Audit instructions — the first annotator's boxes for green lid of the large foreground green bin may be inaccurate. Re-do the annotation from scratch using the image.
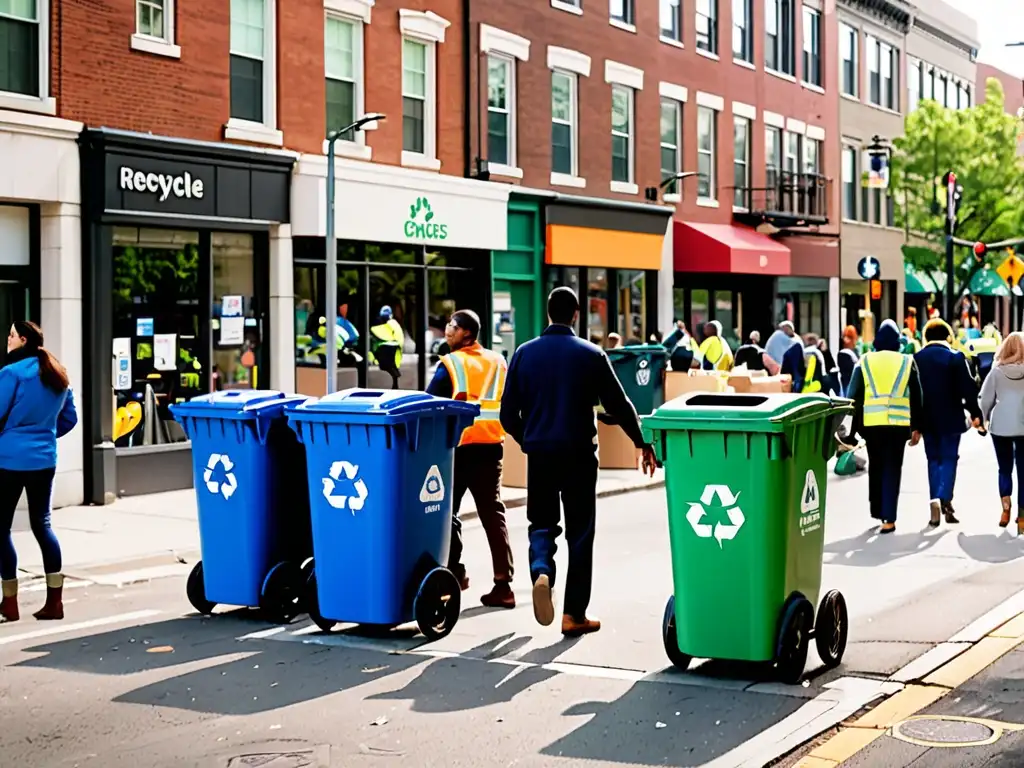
[642,392,853,432]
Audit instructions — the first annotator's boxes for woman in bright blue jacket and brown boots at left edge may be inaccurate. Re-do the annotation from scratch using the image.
[0,321,78,623]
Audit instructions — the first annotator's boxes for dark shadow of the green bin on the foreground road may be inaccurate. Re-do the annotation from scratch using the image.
[541,683,804,766]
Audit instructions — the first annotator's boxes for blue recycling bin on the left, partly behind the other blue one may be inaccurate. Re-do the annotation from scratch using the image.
[171,389,312,624]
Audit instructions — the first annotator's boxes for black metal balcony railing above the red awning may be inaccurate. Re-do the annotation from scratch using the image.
[735,169,831,226]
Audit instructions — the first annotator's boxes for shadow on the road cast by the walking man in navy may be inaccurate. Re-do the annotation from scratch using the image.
[367,633,579,714]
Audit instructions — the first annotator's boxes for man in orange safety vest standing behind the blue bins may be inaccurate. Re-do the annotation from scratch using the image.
[427,309,515,608]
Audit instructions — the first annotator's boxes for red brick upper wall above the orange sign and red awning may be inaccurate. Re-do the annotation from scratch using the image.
[470,0,840,231]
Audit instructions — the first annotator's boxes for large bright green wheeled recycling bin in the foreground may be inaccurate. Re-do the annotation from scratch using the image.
[643,392,852,683]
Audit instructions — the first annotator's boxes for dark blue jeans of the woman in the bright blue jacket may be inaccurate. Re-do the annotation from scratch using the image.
[0,469,61,582]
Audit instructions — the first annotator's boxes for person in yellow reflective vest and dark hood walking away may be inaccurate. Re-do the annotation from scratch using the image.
[845,319,923,534]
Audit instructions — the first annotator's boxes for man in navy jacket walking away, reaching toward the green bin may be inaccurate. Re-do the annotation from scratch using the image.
[501,288,655,637]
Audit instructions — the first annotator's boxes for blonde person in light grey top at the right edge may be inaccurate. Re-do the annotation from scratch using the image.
[981,332,1024,535]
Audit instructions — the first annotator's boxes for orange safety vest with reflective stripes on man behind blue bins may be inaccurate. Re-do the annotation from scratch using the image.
[441,344,508,445]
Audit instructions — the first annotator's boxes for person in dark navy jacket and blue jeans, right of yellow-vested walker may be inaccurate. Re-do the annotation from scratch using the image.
[913,317,978,527]
